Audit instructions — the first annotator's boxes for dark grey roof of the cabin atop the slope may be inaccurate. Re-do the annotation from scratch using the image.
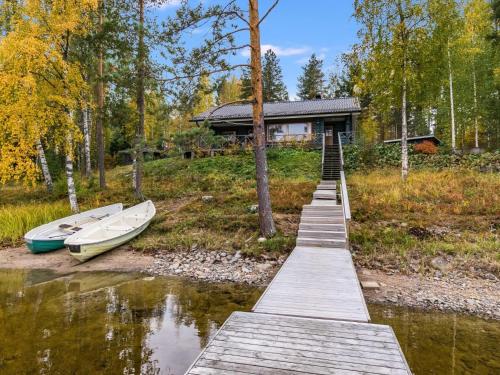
[192,98,361,121]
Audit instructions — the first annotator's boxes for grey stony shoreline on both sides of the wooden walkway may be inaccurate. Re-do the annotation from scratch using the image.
[146,250,500,320]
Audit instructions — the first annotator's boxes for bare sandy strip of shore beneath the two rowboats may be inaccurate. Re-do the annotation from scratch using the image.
[0,247,154,274]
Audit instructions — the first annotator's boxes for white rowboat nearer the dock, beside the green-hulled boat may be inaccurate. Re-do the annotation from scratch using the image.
[64,201,156,262]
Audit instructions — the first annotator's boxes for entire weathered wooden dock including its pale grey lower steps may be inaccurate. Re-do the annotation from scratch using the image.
[186,181,411,375]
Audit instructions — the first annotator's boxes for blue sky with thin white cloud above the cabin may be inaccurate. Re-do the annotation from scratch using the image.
[155,0,357,100]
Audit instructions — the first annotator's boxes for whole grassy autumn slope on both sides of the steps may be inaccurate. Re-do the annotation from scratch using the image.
[0,149,500,273]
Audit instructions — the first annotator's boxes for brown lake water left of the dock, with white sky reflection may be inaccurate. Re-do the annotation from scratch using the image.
[0,270,261,374]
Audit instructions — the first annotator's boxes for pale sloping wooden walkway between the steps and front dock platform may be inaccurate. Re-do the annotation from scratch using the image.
[252,247,370,322]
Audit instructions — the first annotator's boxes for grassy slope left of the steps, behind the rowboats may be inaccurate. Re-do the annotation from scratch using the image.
[0,149,321,255]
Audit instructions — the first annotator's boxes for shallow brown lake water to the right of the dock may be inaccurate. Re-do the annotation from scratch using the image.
[369,305,500,375]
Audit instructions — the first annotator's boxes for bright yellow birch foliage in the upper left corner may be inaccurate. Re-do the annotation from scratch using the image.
[0,0,97,183]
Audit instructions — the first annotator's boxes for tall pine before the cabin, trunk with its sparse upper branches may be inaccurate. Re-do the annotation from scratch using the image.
[165,0,279,237]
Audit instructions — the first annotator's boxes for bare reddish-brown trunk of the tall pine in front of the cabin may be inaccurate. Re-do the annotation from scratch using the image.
[249,0,276,238]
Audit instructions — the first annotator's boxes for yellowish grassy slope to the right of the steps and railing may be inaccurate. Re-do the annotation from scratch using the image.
[348,169,500,273]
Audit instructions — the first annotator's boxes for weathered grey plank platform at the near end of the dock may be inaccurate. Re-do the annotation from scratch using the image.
[186,312,411,375]
